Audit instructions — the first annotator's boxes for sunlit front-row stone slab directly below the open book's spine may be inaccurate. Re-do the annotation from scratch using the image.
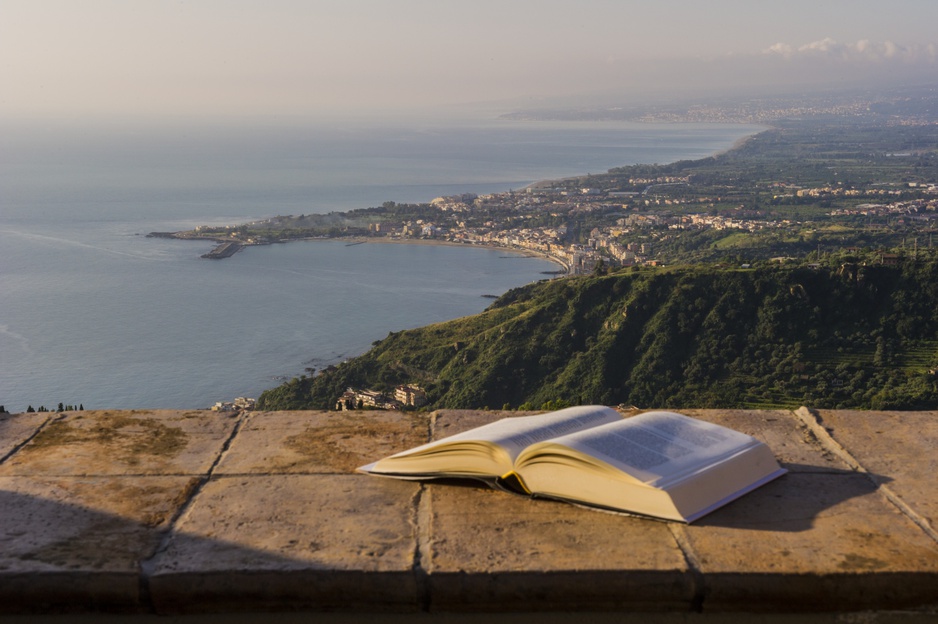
[422,482,694,611]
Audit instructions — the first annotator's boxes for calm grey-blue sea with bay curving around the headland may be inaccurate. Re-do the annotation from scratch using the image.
[0,116,760,412]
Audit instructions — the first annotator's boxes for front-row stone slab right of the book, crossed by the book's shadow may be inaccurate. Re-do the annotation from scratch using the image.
[682,471,938,611]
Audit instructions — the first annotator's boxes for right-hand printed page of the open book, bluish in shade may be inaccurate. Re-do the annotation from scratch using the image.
[532,412,759,486]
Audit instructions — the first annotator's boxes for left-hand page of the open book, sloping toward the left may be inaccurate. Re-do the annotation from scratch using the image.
[391,405,622,460]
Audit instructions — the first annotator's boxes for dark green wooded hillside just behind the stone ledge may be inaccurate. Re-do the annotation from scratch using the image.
[259,257,938,410]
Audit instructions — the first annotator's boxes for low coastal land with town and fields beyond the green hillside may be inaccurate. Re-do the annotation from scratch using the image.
[151,92,938,275]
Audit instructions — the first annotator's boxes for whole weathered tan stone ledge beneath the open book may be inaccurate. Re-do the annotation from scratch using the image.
[0,408,938,614]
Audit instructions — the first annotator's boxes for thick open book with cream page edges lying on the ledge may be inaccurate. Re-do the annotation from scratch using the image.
[359,406,786,522]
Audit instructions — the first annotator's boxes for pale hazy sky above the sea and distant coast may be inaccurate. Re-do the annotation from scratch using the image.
[0,0,938,118]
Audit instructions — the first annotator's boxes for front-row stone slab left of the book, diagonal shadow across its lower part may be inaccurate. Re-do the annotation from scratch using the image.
[148,475,420,613]
